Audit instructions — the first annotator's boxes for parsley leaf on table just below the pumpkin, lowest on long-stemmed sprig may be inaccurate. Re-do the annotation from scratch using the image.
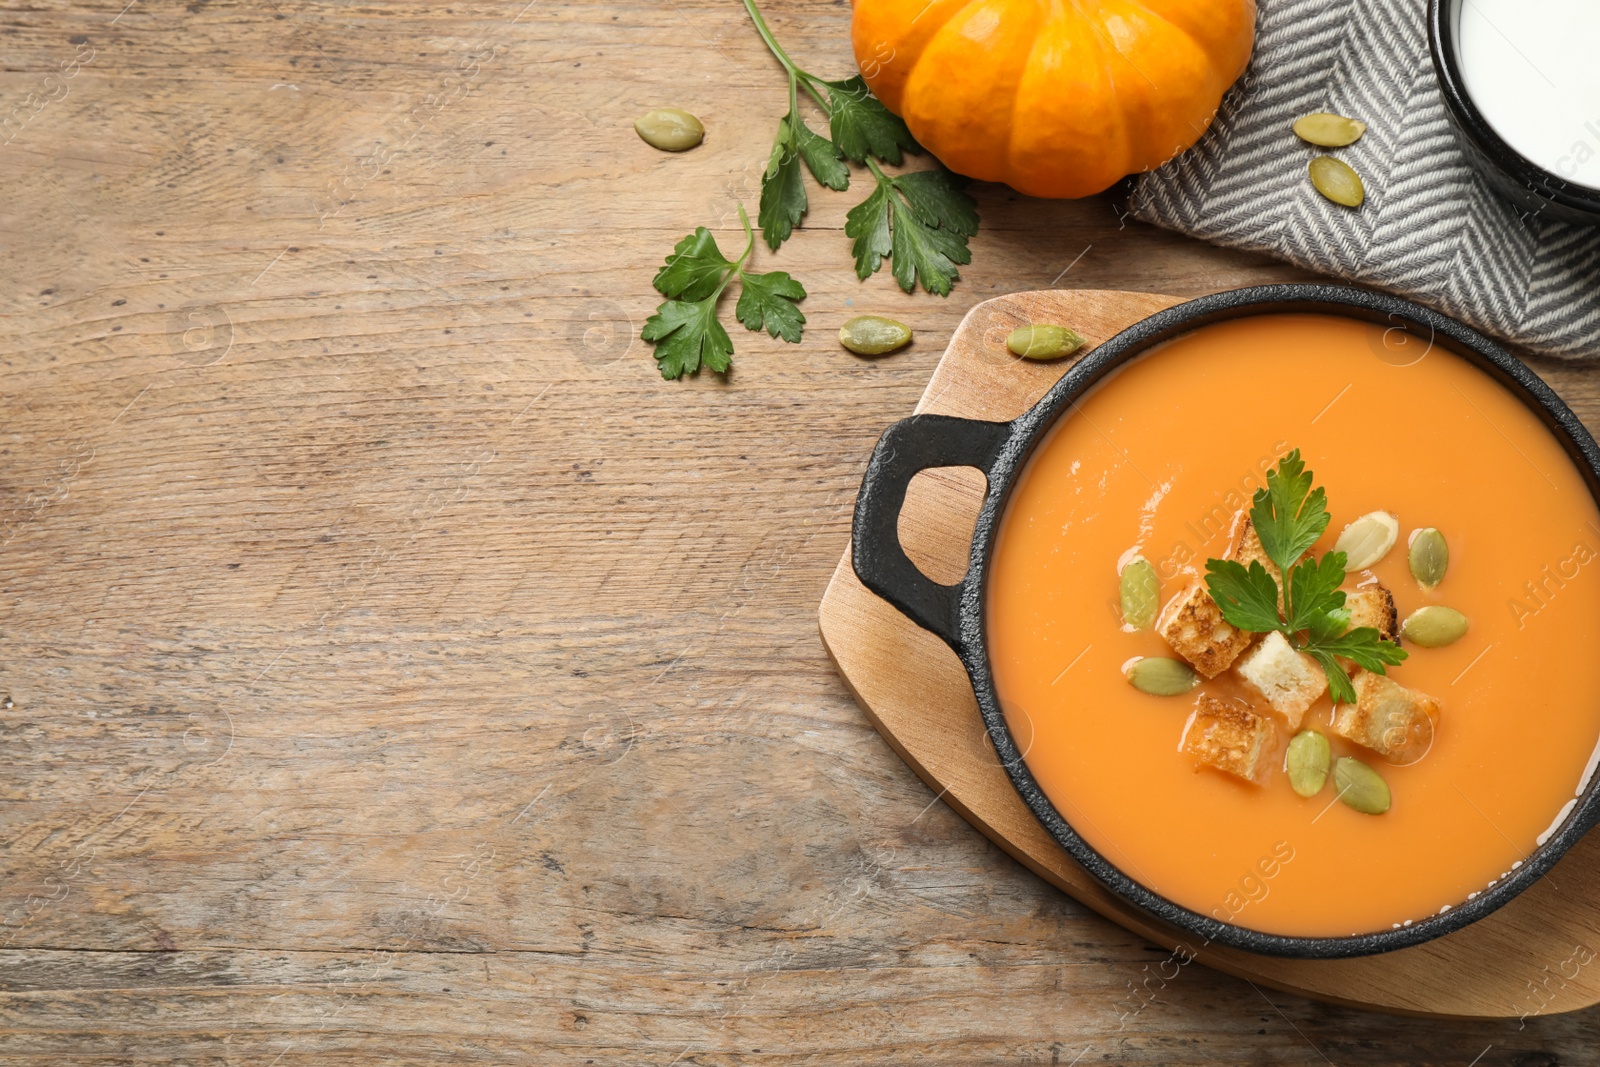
[845,160,978,296]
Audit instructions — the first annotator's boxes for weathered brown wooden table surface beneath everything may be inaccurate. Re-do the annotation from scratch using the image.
[0,0,1600,1067]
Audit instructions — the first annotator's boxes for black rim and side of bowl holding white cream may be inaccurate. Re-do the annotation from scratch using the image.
[1427,0,1600,226]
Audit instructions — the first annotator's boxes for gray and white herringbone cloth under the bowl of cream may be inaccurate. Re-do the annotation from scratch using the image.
[1131,0,1600,357]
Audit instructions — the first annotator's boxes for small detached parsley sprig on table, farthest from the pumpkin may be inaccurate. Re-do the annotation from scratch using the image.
[642,205,805,381]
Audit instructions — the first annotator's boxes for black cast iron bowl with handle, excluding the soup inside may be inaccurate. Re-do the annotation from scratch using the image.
[851,285,1600,960]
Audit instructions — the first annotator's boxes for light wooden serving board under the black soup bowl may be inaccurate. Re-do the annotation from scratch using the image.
[819,290,1600,1019]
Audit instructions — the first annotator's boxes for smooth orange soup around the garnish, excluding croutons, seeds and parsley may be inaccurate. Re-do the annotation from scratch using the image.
[987,315,1600,937]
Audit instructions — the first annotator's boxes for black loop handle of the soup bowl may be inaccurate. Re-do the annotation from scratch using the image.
[851,414,1011,651]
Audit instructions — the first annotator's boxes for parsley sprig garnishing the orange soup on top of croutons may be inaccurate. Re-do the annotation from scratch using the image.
[1205,448,1406,704]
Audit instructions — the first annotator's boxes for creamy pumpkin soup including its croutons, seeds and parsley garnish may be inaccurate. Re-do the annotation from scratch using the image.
[986,315,1600,937]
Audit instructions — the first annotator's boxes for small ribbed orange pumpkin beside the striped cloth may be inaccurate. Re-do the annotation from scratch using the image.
[851,0,1256,197]
